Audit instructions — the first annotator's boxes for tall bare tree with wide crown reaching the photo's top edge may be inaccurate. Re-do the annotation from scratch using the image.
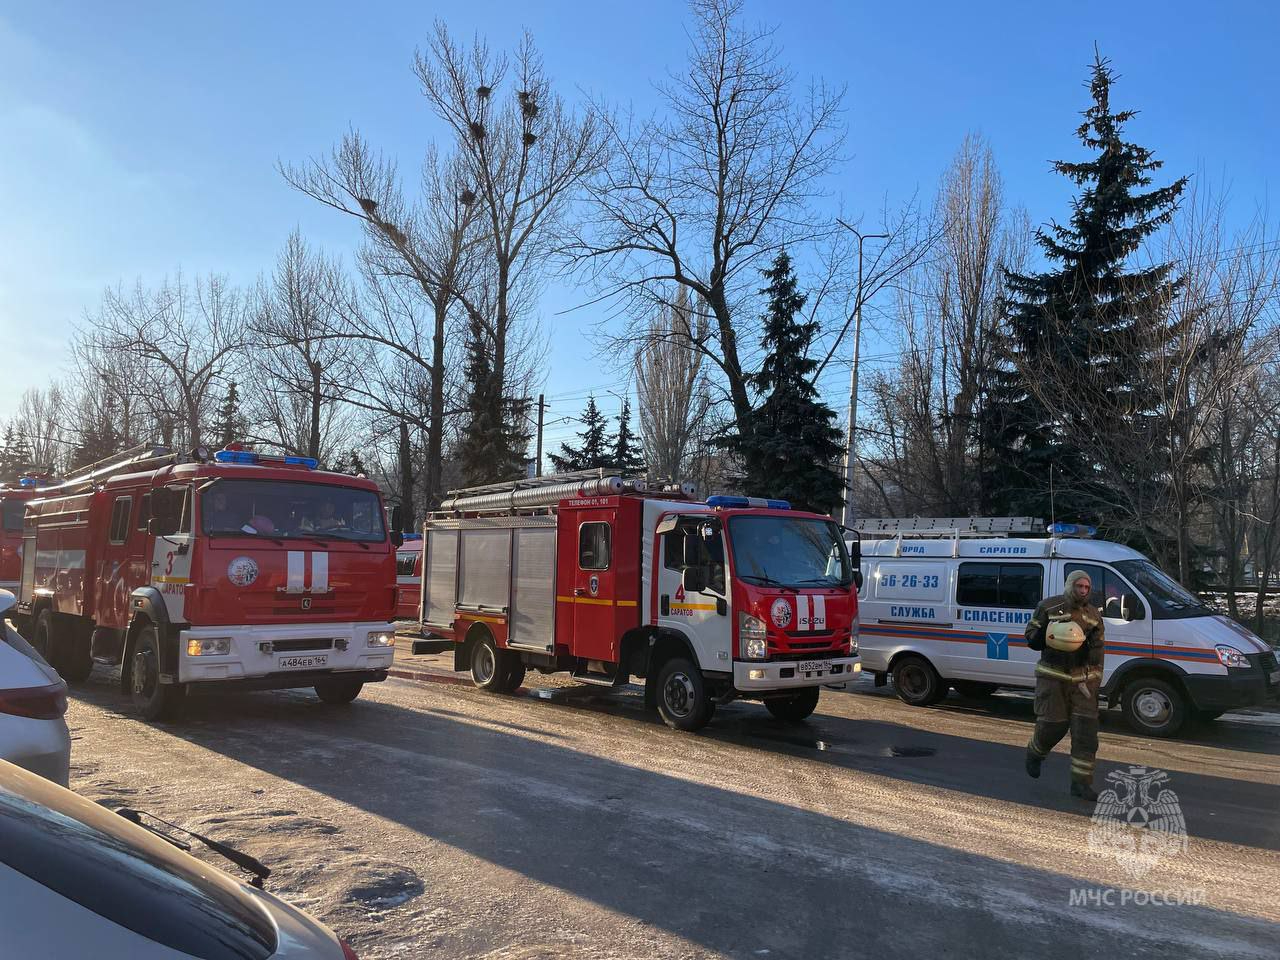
[568,0,842,430]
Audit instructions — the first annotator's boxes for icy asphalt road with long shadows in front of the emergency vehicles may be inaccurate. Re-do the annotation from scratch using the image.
[68,673,1280,960]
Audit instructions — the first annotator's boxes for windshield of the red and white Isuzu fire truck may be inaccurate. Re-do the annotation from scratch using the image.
[728,516,852,588]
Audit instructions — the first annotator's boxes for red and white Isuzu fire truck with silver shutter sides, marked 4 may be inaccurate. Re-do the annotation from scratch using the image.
[415,471,860,730]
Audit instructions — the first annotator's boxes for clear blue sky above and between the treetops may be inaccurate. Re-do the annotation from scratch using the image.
[0,0,1280,453]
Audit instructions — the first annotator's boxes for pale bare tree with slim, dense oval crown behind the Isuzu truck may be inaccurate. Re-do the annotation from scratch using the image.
[635,287,710,481]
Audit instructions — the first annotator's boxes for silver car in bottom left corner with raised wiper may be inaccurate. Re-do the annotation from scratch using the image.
[0,760,356,960]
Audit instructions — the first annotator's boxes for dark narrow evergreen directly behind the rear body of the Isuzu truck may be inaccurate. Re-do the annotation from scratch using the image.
[457,324,530,485]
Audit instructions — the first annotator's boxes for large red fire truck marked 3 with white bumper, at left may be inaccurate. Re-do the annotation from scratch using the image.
[15,444,398,719]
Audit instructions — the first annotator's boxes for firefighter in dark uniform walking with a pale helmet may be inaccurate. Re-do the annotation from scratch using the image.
[1025,570,1103,800]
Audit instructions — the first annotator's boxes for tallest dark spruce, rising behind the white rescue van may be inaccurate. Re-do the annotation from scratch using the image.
[980,55,1187,522]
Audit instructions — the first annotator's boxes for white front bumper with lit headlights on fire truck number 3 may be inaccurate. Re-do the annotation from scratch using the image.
[178,621,396,689]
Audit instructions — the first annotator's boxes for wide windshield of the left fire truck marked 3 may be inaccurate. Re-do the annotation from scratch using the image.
[200,479,387,541]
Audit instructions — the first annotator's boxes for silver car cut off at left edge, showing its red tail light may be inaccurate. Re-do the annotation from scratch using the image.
[0,590,72,786]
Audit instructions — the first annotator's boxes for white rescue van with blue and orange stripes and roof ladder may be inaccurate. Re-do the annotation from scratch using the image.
[856,517,1280,736]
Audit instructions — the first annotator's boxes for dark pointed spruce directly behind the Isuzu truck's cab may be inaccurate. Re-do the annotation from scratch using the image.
[728,250,845,513]
